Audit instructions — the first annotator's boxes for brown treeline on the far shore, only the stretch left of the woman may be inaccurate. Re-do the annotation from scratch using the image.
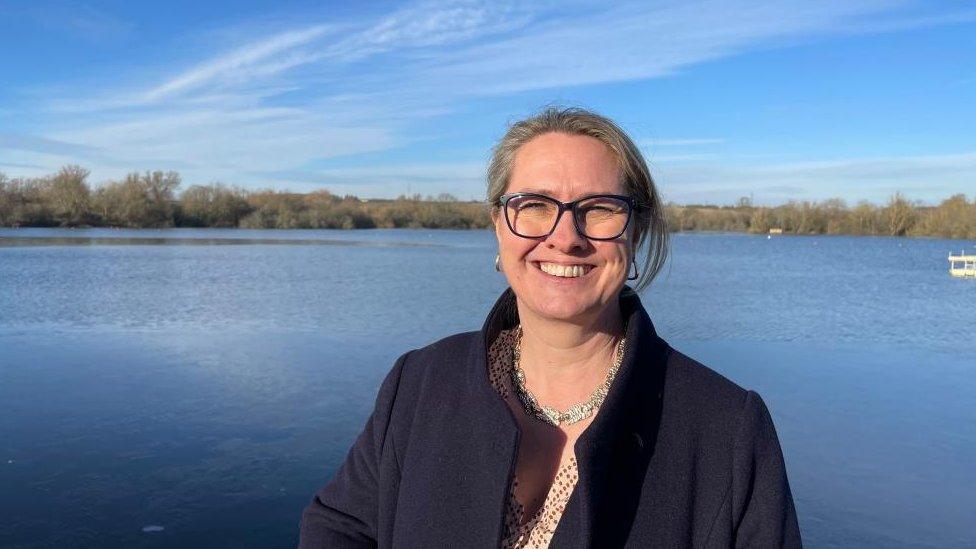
[0,166,491,229]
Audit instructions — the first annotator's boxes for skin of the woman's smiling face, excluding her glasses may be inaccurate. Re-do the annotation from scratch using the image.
[493,133,633,324]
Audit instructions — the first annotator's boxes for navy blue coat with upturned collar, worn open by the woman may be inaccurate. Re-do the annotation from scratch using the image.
[300,289,800,548]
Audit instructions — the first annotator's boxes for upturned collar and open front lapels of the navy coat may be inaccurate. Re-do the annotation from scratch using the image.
[469,286,670,547]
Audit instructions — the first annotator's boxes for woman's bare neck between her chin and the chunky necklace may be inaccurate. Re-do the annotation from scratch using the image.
[510,302,623,409]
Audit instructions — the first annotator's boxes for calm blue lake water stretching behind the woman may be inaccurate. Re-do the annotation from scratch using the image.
[0,229,976,547]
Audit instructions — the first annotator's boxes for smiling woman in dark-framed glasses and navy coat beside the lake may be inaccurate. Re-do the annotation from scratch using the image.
[301,108,800,548]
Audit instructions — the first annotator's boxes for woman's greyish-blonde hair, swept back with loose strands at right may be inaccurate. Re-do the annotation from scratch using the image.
[488,107,669,292]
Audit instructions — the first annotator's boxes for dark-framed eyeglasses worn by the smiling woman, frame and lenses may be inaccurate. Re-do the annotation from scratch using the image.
[498,193,635,240]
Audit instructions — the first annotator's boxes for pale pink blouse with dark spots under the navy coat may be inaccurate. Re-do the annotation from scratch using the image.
[488,330,579,549]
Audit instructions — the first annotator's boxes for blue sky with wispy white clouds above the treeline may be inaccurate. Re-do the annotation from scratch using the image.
[0,0,976,204]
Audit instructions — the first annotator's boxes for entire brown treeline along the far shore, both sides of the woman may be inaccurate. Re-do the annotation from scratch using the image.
[0,166,976,239]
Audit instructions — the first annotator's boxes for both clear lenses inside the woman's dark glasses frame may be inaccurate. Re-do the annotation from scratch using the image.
[505,196,630,238]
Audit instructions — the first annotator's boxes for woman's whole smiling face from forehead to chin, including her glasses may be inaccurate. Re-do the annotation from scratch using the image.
[493,132,640,330]
